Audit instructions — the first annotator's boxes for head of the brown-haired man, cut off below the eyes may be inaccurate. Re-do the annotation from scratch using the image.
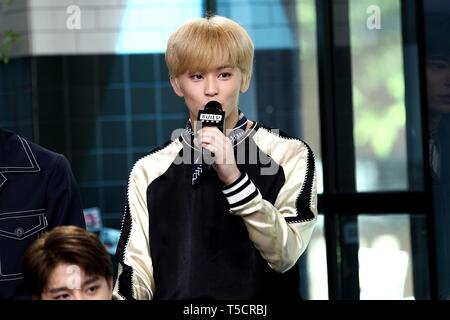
[23,226,112,300]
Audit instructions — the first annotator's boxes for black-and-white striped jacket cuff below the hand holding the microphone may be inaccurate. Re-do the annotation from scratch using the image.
[222,173,258,208]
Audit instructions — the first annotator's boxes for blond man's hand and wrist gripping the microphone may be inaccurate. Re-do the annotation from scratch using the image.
[194,127,241,185]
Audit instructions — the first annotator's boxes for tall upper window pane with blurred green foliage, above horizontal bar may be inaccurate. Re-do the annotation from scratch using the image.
[349,0,408,191]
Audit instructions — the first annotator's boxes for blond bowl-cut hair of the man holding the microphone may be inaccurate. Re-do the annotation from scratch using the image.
[166,16,254,86]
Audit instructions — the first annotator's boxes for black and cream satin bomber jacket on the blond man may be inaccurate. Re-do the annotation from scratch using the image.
[113,123,317,300]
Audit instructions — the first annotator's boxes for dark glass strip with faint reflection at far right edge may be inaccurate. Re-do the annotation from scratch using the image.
[424,1,450,299]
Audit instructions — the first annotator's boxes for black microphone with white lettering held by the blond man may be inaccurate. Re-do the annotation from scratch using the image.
[197,100,225,168]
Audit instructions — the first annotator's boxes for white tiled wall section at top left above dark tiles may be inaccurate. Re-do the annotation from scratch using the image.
[0,0,202,55]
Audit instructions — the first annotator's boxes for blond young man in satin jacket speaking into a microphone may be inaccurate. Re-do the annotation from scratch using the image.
[114,16,317,299]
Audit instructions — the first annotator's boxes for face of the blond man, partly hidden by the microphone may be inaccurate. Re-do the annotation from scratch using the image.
[170,66,247,128]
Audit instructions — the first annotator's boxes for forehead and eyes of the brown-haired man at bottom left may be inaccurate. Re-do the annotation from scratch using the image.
[40,263,112,300]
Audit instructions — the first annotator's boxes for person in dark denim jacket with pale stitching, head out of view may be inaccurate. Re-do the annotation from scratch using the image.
[0,129,85,300]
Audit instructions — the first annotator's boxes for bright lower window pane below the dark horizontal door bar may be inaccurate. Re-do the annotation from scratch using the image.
[358,215,414,300]
